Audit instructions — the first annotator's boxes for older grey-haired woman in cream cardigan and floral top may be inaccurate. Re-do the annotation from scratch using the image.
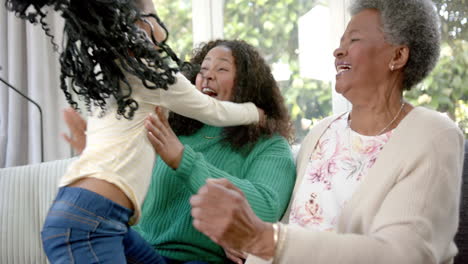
[191,0,463,264]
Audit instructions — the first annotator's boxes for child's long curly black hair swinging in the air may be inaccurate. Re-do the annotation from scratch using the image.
[5,0,185,119]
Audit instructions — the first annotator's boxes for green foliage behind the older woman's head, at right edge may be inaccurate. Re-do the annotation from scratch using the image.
[405,0,468,138]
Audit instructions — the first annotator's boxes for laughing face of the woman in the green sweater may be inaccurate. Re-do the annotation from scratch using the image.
[195,46,236,101]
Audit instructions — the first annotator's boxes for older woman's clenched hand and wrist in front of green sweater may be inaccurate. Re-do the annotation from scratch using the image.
[190,179,275,259]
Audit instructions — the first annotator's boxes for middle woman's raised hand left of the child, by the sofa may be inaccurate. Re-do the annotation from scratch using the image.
[62,107,86,155]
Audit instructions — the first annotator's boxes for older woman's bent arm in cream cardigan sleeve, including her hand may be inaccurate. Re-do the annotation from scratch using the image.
[188,125,463,264]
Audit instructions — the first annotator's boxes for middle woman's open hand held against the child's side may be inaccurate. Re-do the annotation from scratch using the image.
[145,107,184,169]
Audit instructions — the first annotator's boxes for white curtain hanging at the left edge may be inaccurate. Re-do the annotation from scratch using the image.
[0,5,71,168]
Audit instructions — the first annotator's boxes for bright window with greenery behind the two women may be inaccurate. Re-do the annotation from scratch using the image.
[154,0,468,139]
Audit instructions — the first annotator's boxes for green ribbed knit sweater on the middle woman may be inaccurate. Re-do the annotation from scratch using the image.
[134,126,296,263]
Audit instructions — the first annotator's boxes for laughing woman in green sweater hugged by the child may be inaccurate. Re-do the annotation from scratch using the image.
[62,40,296,264]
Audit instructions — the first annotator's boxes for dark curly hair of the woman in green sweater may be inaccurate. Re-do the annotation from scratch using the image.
[169,40,293,149]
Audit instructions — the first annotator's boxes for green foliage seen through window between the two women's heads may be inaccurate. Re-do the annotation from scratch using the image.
[224,0,332,141]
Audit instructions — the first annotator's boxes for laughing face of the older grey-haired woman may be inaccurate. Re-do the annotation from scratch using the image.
[333,9,393,102]
